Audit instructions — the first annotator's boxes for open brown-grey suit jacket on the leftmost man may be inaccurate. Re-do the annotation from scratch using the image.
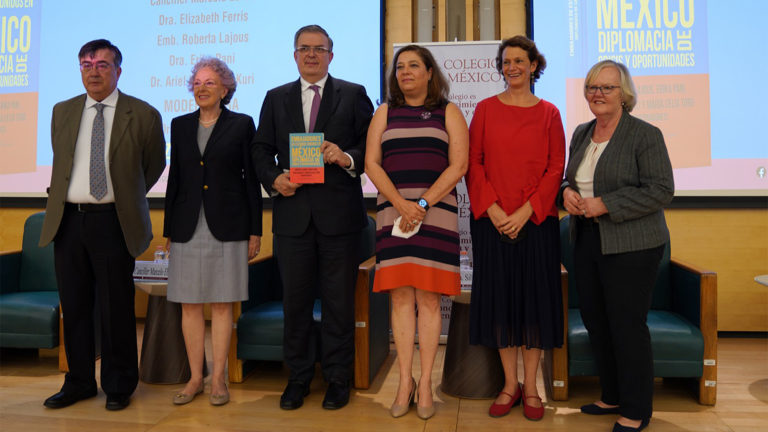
[40,92,165,257]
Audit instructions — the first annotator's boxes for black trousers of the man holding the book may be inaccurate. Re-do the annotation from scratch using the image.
[275,221,361,384]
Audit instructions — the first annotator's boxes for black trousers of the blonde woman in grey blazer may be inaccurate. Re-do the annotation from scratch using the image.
[573,220,664,420]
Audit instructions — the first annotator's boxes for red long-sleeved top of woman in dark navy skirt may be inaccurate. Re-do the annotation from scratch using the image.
[466,96,565,225]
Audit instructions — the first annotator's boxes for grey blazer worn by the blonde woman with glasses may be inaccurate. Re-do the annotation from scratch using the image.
[560,112,675,254]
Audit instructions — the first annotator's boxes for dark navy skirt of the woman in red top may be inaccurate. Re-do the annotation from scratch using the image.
[469,216,563,350]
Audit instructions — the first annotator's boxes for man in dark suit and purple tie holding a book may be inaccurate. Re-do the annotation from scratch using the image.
[253,25,373,409]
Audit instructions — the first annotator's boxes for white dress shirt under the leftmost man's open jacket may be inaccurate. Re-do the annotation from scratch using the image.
[67,89,120,204]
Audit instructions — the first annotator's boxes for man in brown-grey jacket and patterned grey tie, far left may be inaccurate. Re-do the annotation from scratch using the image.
[40,39,165,410]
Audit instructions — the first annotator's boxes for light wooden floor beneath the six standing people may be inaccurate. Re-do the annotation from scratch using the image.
[0,324,768,432]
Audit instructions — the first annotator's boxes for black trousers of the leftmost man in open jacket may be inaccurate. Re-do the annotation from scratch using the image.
[53,205,139,396]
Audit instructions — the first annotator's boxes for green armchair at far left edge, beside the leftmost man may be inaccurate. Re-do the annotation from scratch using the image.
[0,212,59,349]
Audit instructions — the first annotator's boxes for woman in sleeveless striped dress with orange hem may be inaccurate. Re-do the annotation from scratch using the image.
[365,45,469,419]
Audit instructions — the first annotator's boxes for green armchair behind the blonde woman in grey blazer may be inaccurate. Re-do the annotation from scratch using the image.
[544,216,717,405]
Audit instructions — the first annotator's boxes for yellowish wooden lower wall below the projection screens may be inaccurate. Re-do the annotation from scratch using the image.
[0,204,768,332]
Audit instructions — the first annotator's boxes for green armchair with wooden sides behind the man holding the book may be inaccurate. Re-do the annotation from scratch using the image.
[229,216,389,389]
